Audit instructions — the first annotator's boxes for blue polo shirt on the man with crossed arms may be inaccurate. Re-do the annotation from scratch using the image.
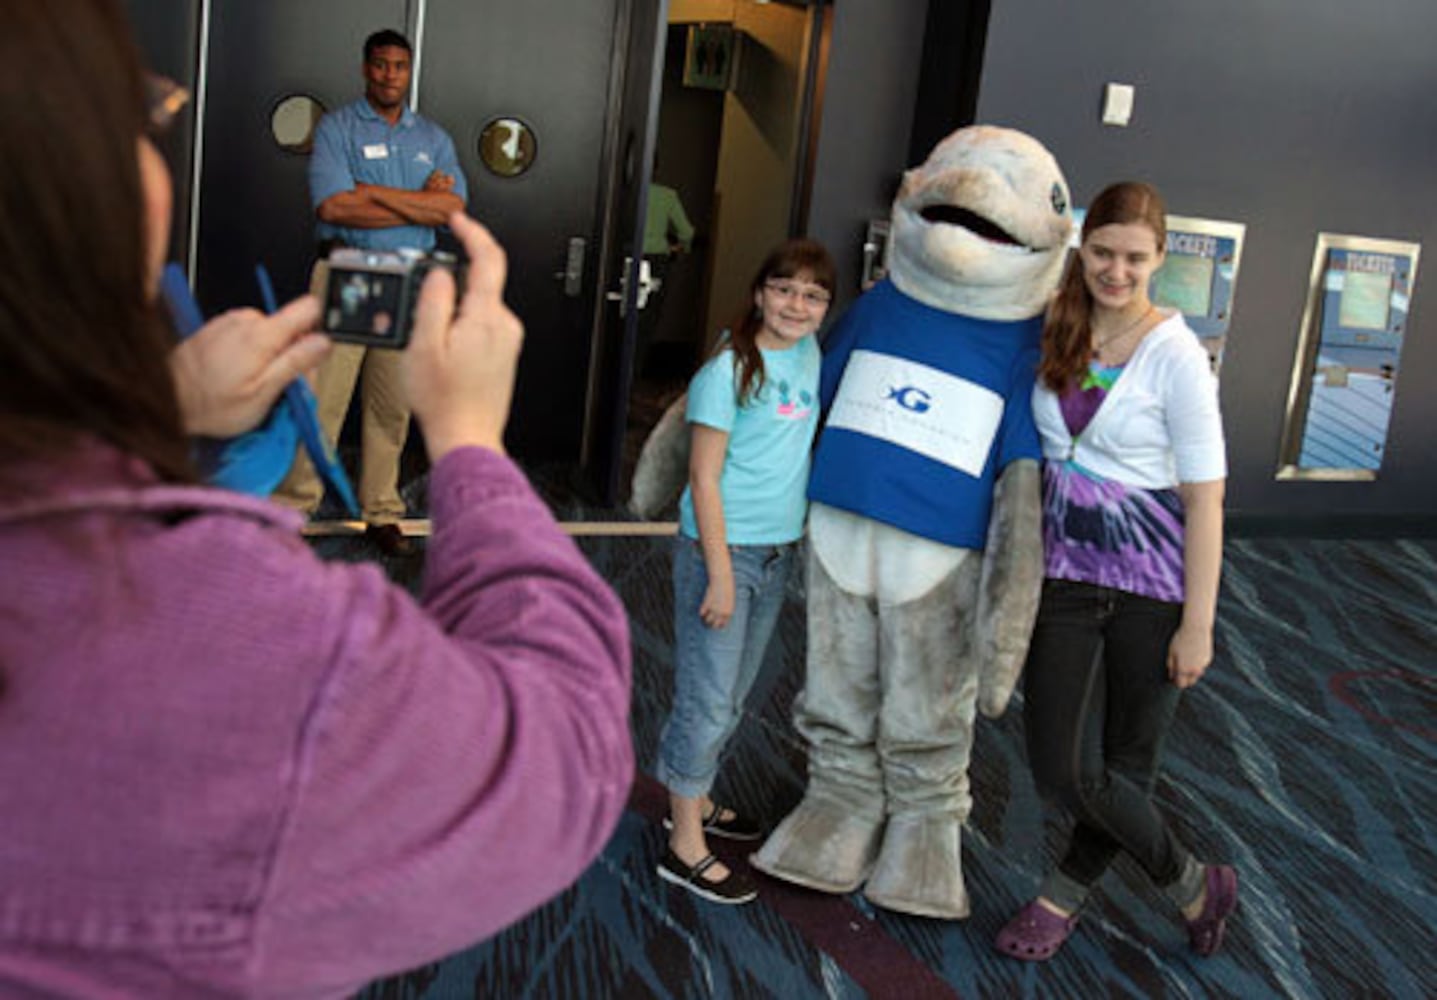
[309,98,468,250]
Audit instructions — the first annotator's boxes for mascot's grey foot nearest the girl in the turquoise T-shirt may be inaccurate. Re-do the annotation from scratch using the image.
[749,796,884,892]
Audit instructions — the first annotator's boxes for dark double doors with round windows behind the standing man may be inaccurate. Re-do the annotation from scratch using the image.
[185,0,667,491]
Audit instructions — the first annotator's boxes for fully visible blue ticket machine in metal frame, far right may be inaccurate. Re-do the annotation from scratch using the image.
[1277,233,1421,480]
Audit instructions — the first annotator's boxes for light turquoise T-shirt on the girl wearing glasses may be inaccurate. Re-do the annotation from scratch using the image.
[678,336,822,545]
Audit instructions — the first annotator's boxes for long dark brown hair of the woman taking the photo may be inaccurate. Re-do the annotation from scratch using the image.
[0,0,194,491]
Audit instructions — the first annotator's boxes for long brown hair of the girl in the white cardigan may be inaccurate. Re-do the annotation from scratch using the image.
[1038,181,1167,392]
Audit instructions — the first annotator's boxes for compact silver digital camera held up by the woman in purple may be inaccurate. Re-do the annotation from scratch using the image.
[313,247,464,351]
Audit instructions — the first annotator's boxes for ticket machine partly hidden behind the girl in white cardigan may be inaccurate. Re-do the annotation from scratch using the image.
[1148,216,1247,374]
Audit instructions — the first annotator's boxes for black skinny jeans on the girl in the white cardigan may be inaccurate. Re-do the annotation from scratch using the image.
[1023,579,1188,886]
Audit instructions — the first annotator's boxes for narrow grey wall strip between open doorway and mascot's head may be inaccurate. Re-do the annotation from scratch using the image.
[808,0,925,303]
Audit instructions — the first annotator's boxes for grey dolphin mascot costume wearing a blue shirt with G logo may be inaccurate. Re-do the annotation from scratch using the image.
[634,126,1072,918]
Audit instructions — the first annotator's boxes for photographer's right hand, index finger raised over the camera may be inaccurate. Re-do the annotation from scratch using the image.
[404,213,523,461]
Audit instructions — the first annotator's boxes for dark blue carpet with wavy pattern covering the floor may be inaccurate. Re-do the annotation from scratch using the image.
[330,539,1437,1000]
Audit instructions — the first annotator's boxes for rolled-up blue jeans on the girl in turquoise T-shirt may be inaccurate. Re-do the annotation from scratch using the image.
[658,534,798,799]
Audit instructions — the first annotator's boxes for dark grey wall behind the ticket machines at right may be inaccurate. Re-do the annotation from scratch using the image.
[977,0,1437,526]
